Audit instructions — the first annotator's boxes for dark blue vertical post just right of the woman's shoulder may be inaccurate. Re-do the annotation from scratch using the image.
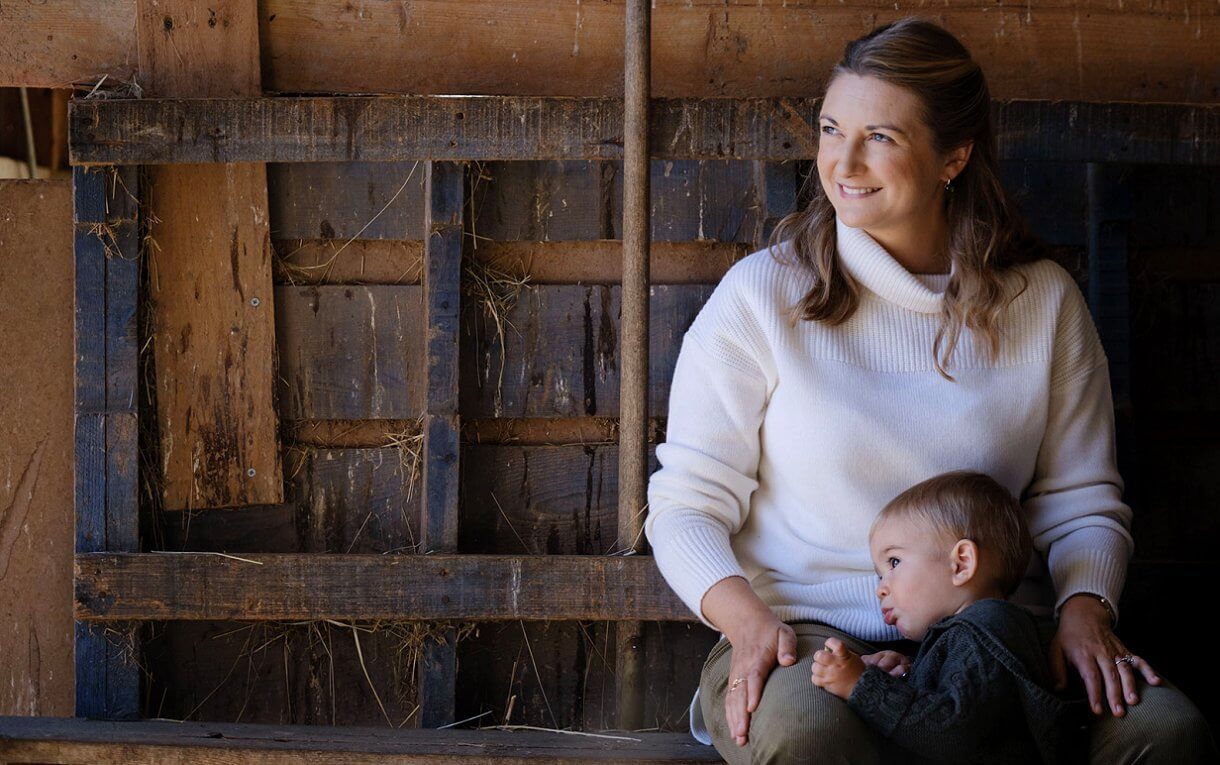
[1086,162,1135,472]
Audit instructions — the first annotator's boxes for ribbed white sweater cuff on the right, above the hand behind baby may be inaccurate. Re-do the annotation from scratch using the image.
[1049,526,1131,623]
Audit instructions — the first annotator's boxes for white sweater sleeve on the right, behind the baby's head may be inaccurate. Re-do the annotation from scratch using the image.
[1024,273,1133,615]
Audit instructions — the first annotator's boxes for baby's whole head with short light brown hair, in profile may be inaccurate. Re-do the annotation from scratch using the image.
[869,471,1033,641]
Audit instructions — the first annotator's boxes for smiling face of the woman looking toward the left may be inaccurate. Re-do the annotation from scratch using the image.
[817,74,965,242]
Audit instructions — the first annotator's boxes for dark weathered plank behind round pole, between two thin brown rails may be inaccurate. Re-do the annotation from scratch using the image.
[461,286,712,417]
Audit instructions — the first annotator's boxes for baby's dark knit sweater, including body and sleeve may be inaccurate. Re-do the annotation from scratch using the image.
[848,598,1089,764]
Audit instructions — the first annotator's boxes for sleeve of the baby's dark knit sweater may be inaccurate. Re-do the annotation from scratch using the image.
[848,631,1021,761]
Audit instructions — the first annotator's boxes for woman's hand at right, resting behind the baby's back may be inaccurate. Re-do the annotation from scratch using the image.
[1049,594,1161,717]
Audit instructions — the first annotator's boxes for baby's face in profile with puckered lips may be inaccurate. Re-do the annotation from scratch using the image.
[869,517,963,641]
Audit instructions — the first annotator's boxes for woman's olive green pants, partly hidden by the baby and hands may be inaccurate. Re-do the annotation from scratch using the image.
[699,621,1218,765]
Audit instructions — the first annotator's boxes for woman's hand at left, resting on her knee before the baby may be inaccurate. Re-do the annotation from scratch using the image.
[703,576,797,747]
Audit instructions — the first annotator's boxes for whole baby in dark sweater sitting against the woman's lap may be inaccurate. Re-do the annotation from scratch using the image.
[813,471,1088,763]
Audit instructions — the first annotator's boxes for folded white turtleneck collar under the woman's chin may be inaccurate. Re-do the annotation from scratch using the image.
[834,217,952,314]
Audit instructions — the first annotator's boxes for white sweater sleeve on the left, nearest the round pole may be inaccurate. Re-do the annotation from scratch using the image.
[644,263,769,628]
